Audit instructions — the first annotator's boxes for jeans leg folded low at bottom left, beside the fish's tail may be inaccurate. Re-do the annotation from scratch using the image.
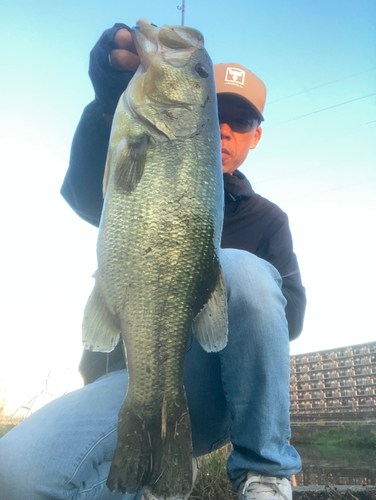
[0,370,143,500]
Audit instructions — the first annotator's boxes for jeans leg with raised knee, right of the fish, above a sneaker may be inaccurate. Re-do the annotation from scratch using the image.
[219,249,301,499]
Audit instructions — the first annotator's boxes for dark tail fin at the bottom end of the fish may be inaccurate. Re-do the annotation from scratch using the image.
[107,396,193,499]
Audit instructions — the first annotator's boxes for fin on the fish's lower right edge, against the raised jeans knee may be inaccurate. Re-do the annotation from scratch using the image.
[192,268,228,352]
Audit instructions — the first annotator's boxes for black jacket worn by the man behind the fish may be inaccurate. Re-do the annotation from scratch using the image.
[61,25,306,383]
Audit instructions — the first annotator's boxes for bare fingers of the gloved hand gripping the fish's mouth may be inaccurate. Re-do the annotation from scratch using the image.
[110,19,150,71]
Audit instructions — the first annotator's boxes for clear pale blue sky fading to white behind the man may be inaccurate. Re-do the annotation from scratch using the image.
[0,0,376,414]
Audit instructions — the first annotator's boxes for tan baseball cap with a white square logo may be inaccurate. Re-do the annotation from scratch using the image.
[214,63,266,121]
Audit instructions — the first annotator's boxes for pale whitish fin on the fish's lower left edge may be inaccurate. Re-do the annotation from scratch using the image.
[82,285,120,352]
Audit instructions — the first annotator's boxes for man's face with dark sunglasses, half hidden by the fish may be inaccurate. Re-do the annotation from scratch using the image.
[217,94,262,175]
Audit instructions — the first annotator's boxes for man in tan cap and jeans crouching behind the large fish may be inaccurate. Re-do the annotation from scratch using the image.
[0,20,305,500]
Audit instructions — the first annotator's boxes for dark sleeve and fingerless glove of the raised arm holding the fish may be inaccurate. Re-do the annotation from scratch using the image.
[60,23,134,226]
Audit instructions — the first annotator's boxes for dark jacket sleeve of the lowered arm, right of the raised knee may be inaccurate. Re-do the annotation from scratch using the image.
[259,210,307,340]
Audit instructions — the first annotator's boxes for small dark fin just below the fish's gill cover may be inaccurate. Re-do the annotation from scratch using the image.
[115,133,149,193]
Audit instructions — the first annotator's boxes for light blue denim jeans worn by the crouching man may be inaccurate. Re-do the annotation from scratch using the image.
[0,249,301,500]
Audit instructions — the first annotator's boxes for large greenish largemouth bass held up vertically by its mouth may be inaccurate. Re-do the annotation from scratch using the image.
[82,24,228,500]
